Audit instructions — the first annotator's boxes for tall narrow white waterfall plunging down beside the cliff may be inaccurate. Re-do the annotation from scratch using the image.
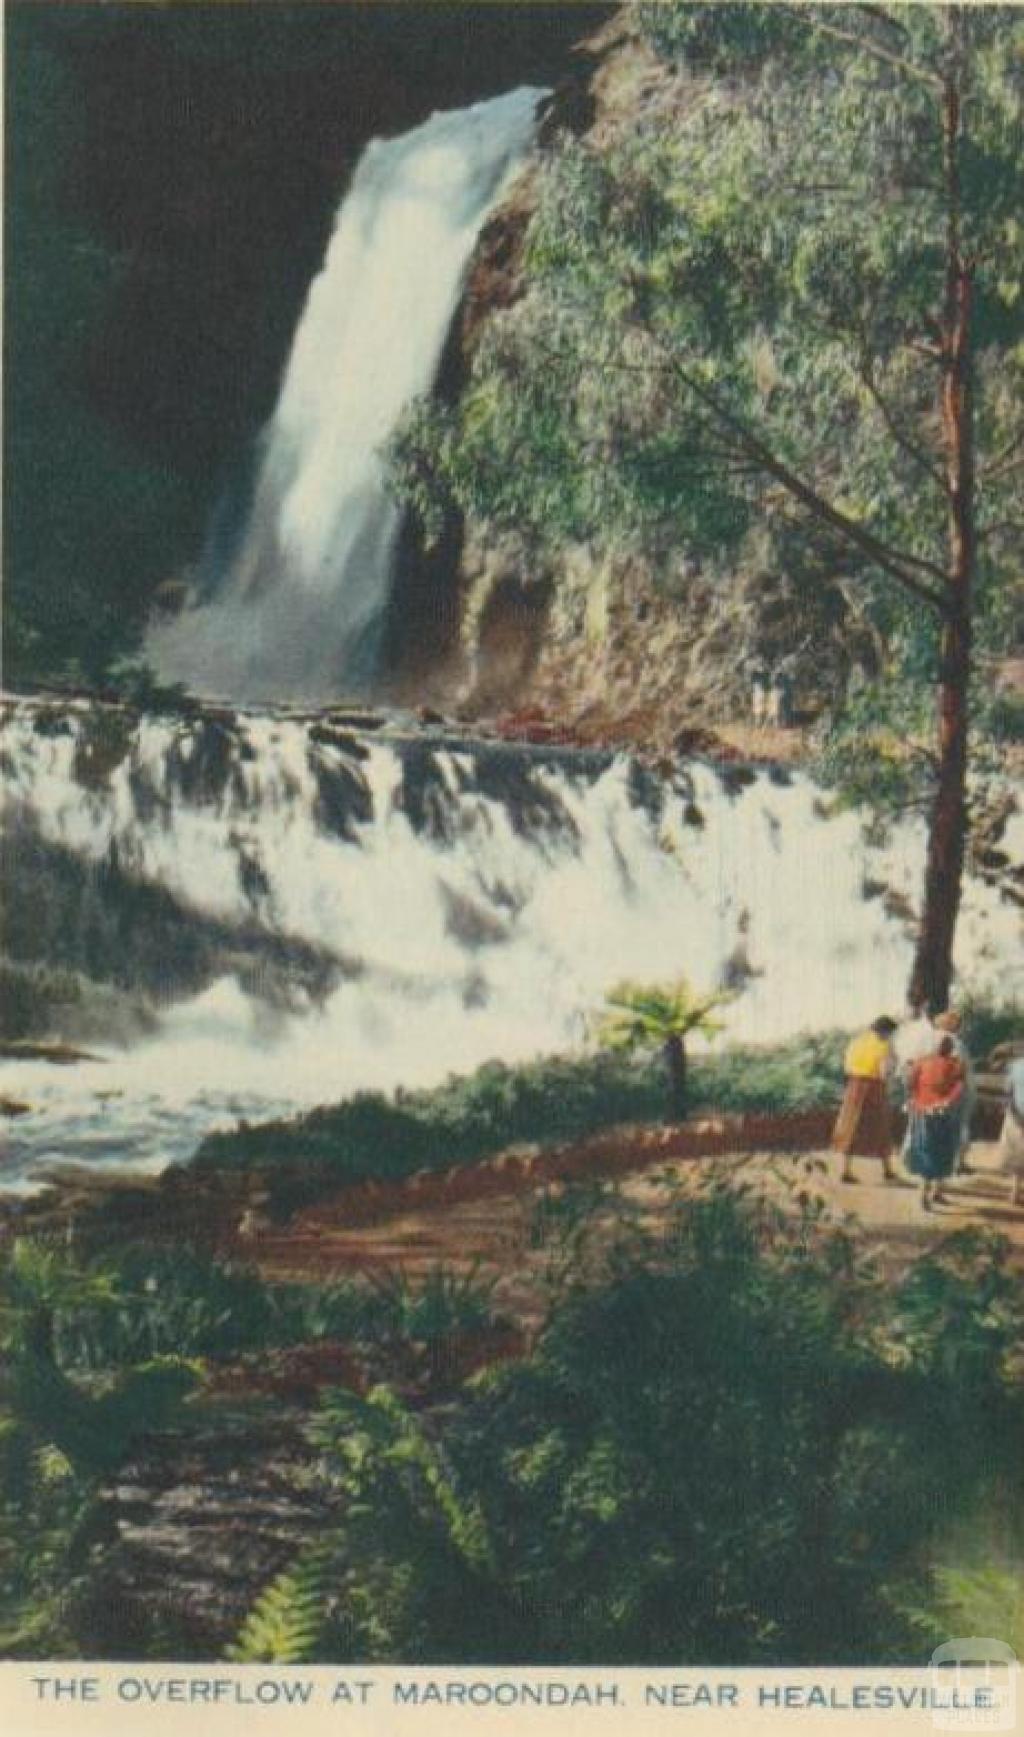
[148,89,543,703]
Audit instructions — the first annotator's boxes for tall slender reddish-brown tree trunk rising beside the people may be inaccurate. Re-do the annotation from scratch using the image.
[909,7,977,1007]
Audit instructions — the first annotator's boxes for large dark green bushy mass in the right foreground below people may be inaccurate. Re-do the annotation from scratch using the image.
[230,1183,1024,1664]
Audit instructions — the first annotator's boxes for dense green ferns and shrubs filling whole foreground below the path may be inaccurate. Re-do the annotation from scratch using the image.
[0,1171,1024,1664]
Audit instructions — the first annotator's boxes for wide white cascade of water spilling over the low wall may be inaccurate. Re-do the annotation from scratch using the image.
[0,703,1024,1188]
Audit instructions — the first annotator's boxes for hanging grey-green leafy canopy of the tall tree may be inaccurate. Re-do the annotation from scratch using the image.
[394,0,1024,788]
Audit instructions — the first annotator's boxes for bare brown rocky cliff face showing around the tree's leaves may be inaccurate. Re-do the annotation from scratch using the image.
[443,9,880,743]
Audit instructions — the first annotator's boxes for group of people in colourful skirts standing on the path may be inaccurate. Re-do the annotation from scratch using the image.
[831,1004,1024,1212]
